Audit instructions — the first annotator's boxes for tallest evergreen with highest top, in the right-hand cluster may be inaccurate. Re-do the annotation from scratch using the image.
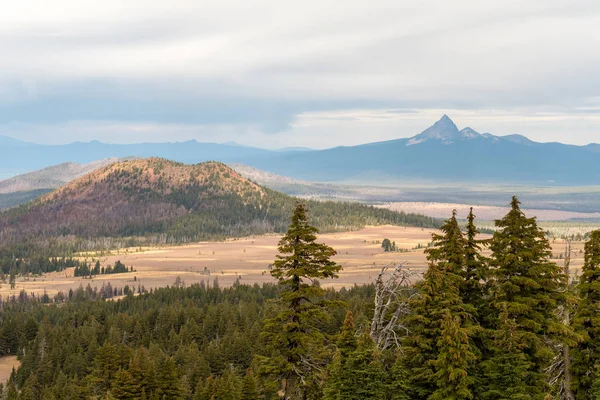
[490,197,574,399]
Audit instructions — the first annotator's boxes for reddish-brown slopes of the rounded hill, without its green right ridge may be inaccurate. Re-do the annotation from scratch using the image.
[0,158,264,245]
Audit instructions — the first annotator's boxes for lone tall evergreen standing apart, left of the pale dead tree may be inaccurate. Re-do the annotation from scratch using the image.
[264,204,341,400]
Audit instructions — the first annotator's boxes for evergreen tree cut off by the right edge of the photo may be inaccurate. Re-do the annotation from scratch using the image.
[572,230,600,400]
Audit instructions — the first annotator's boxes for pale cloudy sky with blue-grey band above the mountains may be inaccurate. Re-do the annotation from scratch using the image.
[0,0,600,148]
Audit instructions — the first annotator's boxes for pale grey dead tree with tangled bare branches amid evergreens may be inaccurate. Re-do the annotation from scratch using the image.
[370,263,417,350]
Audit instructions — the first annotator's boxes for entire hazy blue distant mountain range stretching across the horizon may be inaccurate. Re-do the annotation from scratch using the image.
[0,115,600,186]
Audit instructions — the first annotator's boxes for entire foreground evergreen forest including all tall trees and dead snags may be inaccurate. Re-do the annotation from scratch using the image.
[7,198,600,400]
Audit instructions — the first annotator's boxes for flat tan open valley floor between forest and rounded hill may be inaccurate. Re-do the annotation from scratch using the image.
[0,225,583,297]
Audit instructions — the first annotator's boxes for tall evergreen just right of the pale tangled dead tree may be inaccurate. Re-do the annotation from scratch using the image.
[406,211,479,400]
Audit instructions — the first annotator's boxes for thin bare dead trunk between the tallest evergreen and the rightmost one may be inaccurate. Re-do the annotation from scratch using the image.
[547,239,575,400]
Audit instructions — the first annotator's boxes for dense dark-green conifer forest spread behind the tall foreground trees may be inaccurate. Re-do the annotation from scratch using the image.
[0,285,373,400]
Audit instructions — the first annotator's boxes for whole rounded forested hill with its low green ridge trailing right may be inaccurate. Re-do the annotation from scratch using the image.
[0,158,438,250]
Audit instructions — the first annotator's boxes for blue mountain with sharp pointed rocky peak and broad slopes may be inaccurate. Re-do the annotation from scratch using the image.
[241,115,600,186]
